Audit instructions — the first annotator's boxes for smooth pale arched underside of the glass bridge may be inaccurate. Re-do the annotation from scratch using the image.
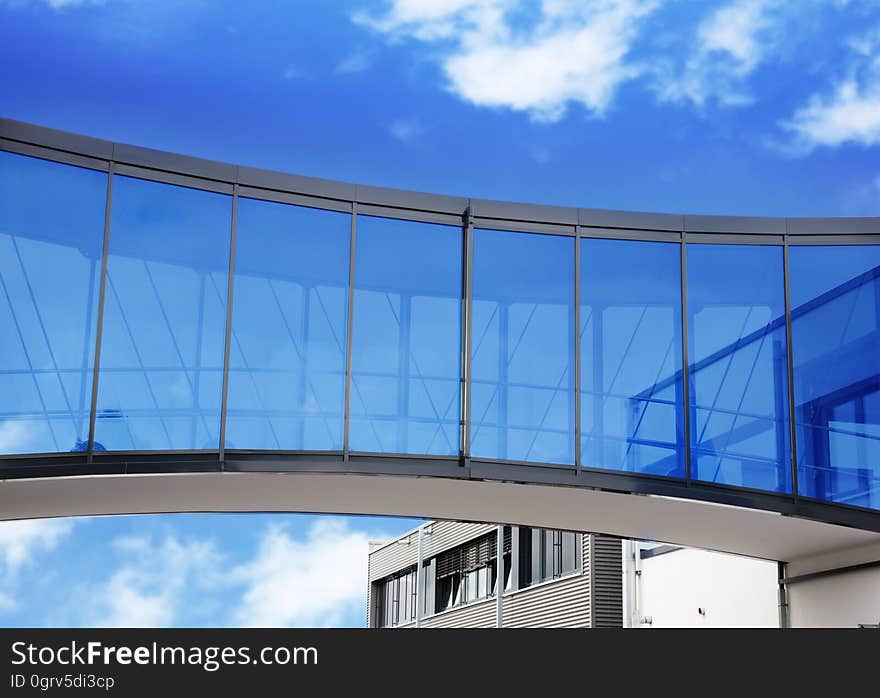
[0,463,880,570]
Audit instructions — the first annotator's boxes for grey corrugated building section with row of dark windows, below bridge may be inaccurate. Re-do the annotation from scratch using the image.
[367,521,623,628]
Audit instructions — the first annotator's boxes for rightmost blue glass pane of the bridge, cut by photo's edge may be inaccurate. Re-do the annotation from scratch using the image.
[789,245,880,509]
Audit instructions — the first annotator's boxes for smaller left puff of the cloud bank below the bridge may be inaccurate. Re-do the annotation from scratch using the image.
[86,535,222,627]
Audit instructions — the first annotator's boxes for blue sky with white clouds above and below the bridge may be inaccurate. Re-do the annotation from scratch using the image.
[0,0,880,625]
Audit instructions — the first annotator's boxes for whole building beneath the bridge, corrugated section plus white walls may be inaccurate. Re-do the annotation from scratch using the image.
[367,521,880,628]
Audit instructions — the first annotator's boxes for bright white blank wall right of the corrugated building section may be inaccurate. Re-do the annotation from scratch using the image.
[635,548,779,628]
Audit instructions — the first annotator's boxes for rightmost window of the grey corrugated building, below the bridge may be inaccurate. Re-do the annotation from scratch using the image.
[518,528,581,588]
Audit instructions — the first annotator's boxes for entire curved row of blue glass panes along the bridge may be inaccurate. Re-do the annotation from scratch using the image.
[0,126,880,510]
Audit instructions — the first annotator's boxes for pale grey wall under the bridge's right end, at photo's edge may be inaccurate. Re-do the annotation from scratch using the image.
[788,567,880,628]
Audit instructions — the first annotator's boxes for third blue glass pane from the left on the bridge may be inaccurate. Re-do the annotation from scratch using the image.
[226,199,351,450]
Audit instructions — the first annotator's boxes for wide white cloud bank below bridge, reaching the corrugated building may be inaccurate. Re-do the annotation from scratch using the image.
[68,518,396,627]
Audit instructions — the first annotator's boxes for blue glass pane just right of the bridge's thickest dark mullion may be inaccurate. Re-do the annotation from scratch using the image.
[471,230,575,463]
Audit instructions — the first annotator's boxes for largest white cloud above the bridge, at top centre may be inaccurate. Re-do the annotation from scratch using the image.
[355,0,662,121]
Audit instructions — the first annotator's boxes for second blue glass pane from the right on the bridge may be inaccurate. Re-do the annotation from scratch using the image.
[687,244,791,492]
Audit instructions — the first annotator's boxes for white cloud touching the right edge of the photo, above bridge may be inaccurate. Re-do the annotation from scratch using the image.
[781,28,880,154]
